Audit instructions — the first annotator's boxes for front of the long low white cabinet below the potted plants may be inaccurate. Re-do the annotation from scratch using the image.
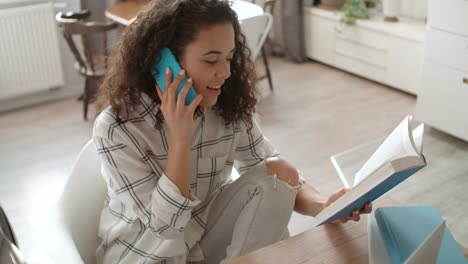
[304,6,426,94]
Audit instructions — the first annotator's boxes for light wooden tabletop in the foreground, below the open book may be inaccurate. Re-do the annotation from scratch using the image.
[228,219,368,264]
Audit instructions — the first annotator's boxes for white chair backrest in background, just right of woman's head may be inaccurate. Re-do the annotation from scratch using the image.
[240,13,273,59]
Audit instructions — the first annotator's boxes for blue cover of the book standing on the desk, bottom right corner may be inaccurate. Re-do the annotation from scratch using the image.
[375,206,468,264]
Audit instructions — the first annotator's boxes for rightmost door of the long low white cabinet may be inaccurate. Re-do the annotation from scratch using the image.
[385,38,424,94]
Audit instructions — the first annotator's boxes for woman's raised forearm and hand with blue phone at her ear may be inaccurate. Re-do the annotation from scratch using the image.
[151,49,203,199]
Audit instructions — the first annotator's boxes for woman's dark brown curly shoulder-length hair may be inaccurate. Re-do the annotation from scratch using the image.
[96,0,257,129]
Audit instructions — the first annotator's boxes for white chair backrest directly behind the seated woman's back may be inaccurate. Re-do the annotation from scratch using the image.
[59,141,107,264]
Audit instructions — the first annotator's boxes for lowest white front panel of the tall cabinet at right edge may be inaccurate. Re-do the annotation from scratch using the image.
[416,60,468,140]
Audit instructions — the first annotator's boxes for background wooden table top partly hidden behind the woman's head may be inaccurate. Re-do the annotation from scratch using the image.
[105,0,263,26]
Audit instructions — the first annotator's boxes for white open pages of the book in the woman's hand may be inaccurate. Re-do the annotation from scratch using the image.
[353,116,422,186]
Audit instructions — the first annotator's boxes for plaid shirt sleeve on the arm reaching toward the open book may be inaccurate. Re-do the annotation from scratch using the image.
[234,116,279,175]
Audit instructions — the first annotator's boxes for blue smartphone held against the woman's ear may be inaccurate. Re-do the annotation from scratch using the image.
[151,48,197,105]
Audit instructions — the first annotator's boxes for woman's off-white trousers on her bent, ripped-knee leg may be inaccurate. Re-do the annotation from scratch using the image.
[194,163,300,264]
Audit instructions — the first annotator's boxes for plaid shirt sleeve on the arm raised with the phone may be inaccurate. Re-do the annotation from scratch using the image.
[93,122,200,238]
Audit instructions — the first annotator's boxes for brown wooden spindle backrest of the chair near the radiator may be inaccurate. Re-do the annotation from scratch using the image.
[55,10,118,75]
